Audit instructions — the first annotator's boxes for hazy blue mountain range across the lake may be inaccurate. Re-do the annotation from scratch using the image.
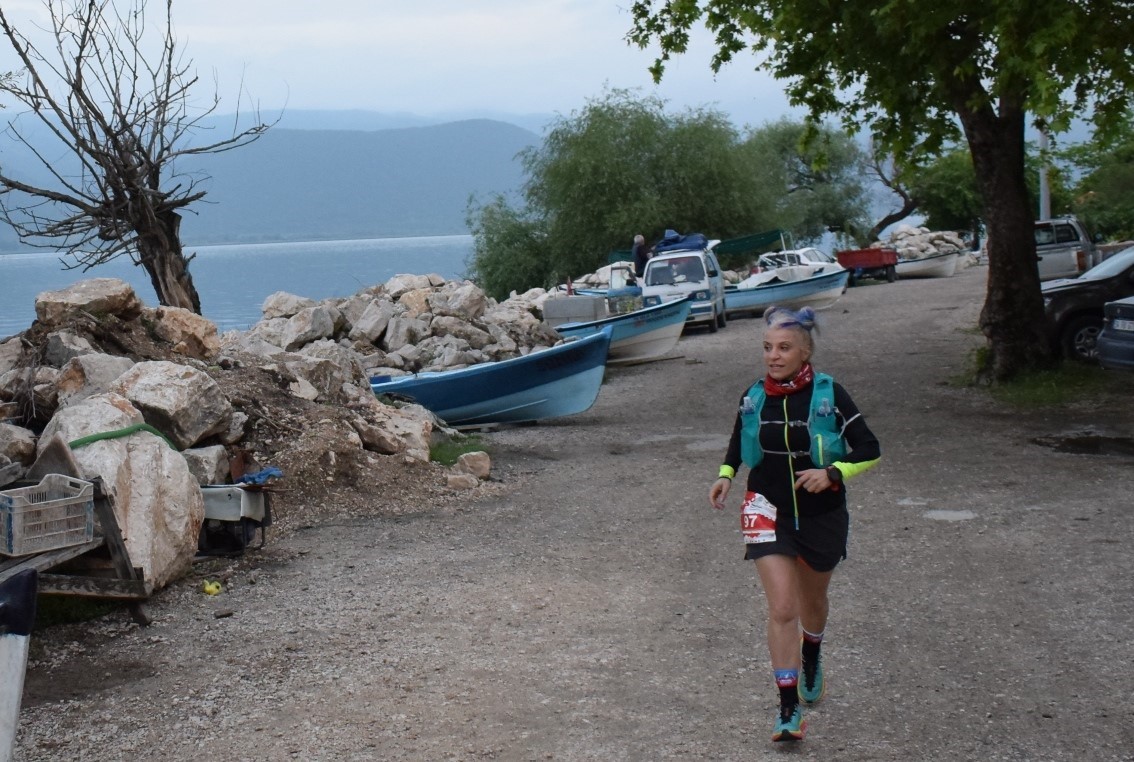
[0,111,540,251]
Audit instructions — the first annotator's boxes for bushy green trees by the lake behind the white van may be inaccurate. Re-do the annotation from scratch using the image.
[468,91,865,298]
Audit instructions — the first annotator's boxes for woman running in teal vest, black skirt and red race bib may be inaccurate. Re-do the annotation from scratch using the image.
[709,307,881,740]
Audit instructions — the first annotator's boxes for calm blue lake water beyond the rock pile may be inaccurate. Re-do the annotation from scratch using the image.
[0,236,473,338]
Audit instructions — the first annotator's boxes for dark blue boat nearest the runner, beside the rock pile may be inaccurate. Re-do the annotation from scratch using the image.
[370,327,613,426]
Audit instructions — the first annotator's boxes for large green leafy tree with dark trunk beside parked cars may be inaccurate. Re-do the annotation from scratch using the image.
[629,0,1134,379]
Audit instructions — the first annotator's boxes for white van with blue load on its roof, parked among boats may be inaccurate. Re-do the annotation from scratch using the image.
[640,240,726,332]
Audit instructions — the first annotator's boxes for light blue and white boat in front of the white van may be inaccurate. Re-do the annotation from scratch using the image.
[556,298,693,364]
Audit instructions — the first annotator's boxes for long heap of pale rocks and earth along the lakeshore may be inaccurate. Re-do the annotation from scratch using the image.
[0,276,559,590]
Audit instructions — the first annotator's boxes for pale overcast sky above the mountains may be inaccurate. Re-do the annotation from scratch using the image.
[0,0,798,130]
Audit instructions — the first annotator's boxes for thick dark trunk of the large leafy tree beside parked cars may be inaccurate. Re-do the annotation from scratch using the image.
[958,103,1055,381]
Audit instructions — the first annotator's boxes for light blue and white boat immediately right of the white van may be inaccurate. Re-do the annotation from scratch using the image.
[725,264,851,318]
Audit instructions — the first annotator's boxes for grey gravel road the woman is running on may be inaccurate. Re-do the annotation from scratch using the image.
[17,269,1134,761]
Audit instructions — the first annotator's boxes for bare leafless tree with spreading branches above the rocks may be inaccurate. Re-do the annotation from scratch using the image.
[0,0,271,313]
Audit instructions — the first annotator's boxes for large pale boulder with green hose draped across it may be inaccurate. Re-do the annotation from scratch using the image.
[41,393,204,590]
